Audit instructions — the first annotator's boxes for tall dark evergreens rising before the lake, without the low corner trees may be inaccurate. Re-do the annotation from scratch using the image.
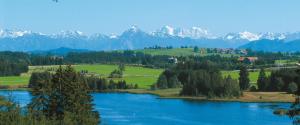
[29,66,99,125]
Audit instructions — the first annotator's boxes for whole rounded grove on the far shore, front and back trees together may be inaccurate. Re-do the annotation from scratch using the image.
[153,61,241,97]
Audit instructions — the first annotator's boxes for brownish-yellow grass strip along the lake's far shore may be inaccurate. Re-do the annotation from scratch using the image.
[119,88,295,102]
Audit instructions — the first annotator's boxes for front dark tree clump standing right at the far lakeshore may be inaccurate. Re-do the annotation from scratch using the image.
[181,70,241,97]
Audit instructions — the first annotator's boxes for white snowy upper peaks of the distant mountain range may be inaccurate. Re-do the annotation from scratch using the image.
[0,25,294,41]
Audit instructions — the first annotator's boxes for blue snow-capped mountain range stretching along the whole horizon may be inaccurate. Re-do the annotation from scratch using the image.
[0,26,300,52]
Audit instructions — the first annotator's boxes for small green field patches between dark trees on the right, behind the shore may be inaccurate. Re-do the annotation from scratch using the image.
[222,71,271,86]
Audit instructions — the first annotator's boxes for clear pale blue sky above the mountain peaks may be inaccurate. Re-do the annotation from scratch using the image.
[0,0,300,34]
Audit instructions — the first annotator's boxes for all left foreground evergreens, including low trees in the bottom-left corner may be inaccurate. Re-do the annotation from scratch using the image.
[0,66,100,125]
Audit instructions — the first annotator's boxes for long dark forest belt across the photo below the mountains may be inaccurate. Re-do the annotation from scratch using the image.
[0,50,298,76]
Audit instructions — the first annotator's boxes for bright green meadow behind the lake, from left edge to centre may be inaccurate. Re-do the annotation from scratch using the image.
[0,64,163,88]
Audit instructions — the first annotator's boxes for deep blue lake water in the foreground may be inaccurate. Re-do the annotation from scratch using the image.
[0,91,292,125]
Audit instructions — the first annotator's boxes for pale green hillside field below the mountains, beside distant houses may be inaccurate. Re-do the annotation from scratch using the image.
[135,48,238,57]
